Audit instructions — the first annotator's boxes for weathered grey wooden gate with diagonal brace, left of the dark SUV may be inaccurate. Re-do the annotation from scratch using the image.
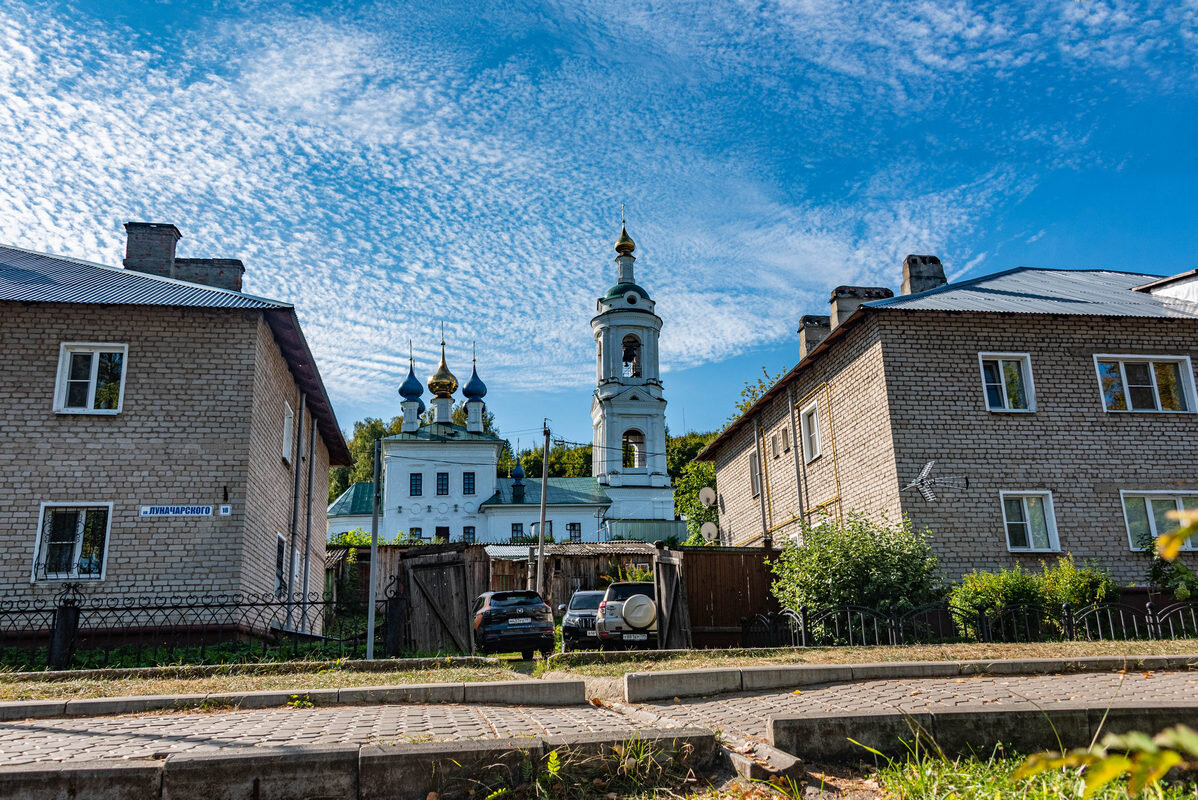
[404,551,474,653]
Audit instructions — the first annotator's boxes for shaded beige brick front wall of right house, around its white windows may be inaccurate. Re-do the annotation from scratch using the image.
[878,311,1198,584]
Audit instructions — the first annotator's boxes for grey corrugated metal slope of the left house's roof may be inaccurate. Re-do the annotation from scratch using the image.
[0,244,291,309]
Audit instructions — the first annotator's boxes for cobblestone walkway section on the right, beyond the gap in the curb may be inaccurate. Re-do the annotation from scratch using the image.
[639,672,1198,741]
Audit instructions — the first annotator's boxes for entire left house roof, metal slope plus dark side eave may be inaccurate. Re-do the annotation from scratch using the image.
[0,244,353,466]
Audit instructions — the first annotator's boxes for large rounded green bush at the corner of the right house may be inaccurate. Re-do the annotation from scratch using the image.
[773,511,944,611]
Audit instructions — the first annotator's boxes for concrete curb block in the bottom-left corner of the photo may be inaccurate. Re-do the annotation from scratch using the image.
[0,760,162,800]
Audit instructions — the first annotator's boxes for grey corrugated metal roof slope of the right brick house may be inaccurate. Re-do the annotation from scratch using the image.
[865,267,1198,317]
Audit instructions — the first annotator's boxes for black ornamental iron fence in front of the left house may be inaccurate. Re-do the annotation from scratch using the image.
[0,580,406,669]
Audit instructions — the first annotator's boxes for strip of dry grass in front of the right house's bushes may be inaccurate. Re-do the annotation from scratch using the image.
[549,640,1198,678]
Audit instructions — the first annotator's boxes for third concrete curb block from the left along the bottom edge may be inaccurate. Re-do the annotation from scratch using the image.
[357,738,543,800]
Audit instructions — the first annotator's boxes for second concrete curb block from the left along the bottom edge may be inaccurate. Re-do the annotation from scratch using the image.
[162,745,358,800]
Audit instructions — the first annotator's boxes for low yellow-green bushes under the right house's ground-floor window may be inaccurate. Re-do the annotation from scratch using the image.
[949,556,1119,613]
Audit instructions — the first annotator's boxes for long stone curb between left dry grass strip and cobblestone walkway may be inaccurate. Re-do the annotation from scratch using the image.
[0,680,587,722]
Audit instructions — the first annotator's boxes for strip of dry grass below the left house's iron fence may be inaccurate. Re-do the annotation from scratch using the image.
[0,667,525,701]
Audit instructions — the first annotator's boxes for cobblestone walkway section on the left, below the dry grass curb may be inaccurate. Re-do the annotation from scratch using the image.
[0,705,636,765]
